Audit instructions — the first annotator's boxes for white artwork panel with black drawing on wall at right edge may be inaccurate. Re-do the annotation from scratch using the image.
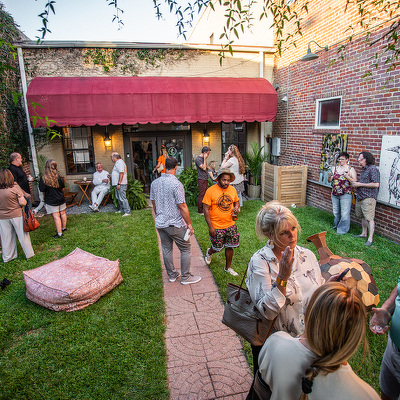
[378,135,400,206]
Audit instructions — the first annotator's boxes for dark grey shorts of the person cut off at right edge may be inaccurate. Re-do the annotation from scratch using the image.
[379,335,400,399]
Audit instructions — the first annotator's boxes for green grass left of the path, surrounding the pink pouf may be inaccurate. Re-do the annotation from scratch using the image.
[0,210,169,400]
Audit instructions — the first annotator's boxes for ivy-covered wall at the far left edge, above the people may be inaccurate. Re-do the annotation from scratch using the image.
[0,4,29,168]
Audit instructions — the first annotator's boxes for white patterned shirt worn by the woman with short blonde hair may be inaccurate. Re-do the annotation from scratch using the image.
[246,243,325,337]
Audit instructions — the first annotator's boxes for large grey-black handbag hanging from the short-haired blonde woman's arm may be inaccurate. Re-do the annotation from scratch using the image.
[222,268,276,346]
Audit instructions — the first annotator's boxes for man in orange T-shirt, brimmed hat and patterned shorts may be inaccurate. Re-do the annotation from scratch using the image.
[203,168,239,276]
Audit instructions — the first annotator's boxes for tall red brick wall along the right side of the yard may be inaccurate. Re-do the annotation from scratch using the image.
[273,0,400,242]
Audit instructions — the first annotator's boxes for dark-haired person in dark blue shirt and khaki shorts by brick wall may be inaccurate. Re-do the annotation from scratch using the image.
[351,151,380,246]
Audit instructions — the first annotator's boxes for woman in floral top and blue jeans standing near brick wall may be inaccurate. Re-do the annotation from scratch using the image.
[328,151,357,235]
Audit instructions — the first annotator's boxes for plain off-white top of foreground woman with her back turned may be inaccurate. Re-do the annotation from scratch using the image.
[258,332,380,400]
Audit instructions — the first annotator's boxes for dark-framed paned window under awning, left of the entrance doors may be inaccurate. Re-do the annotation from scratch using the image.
[63,126,95,174]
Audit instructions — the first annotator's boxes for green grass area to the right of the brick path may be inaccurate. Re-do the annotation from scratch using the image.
[190,200,400,393]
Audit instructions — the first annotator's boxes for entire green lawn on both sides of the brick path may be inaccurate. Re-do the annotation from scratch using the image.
[0,200,400,400]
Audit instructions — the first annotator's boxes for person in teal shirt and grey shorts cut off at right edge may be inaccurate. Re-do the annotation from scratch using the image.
[369,276,400,400]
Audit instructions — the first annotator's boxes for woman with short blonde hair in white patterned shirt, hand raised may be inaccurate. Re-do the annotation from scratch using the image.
[246,201,325,373]
